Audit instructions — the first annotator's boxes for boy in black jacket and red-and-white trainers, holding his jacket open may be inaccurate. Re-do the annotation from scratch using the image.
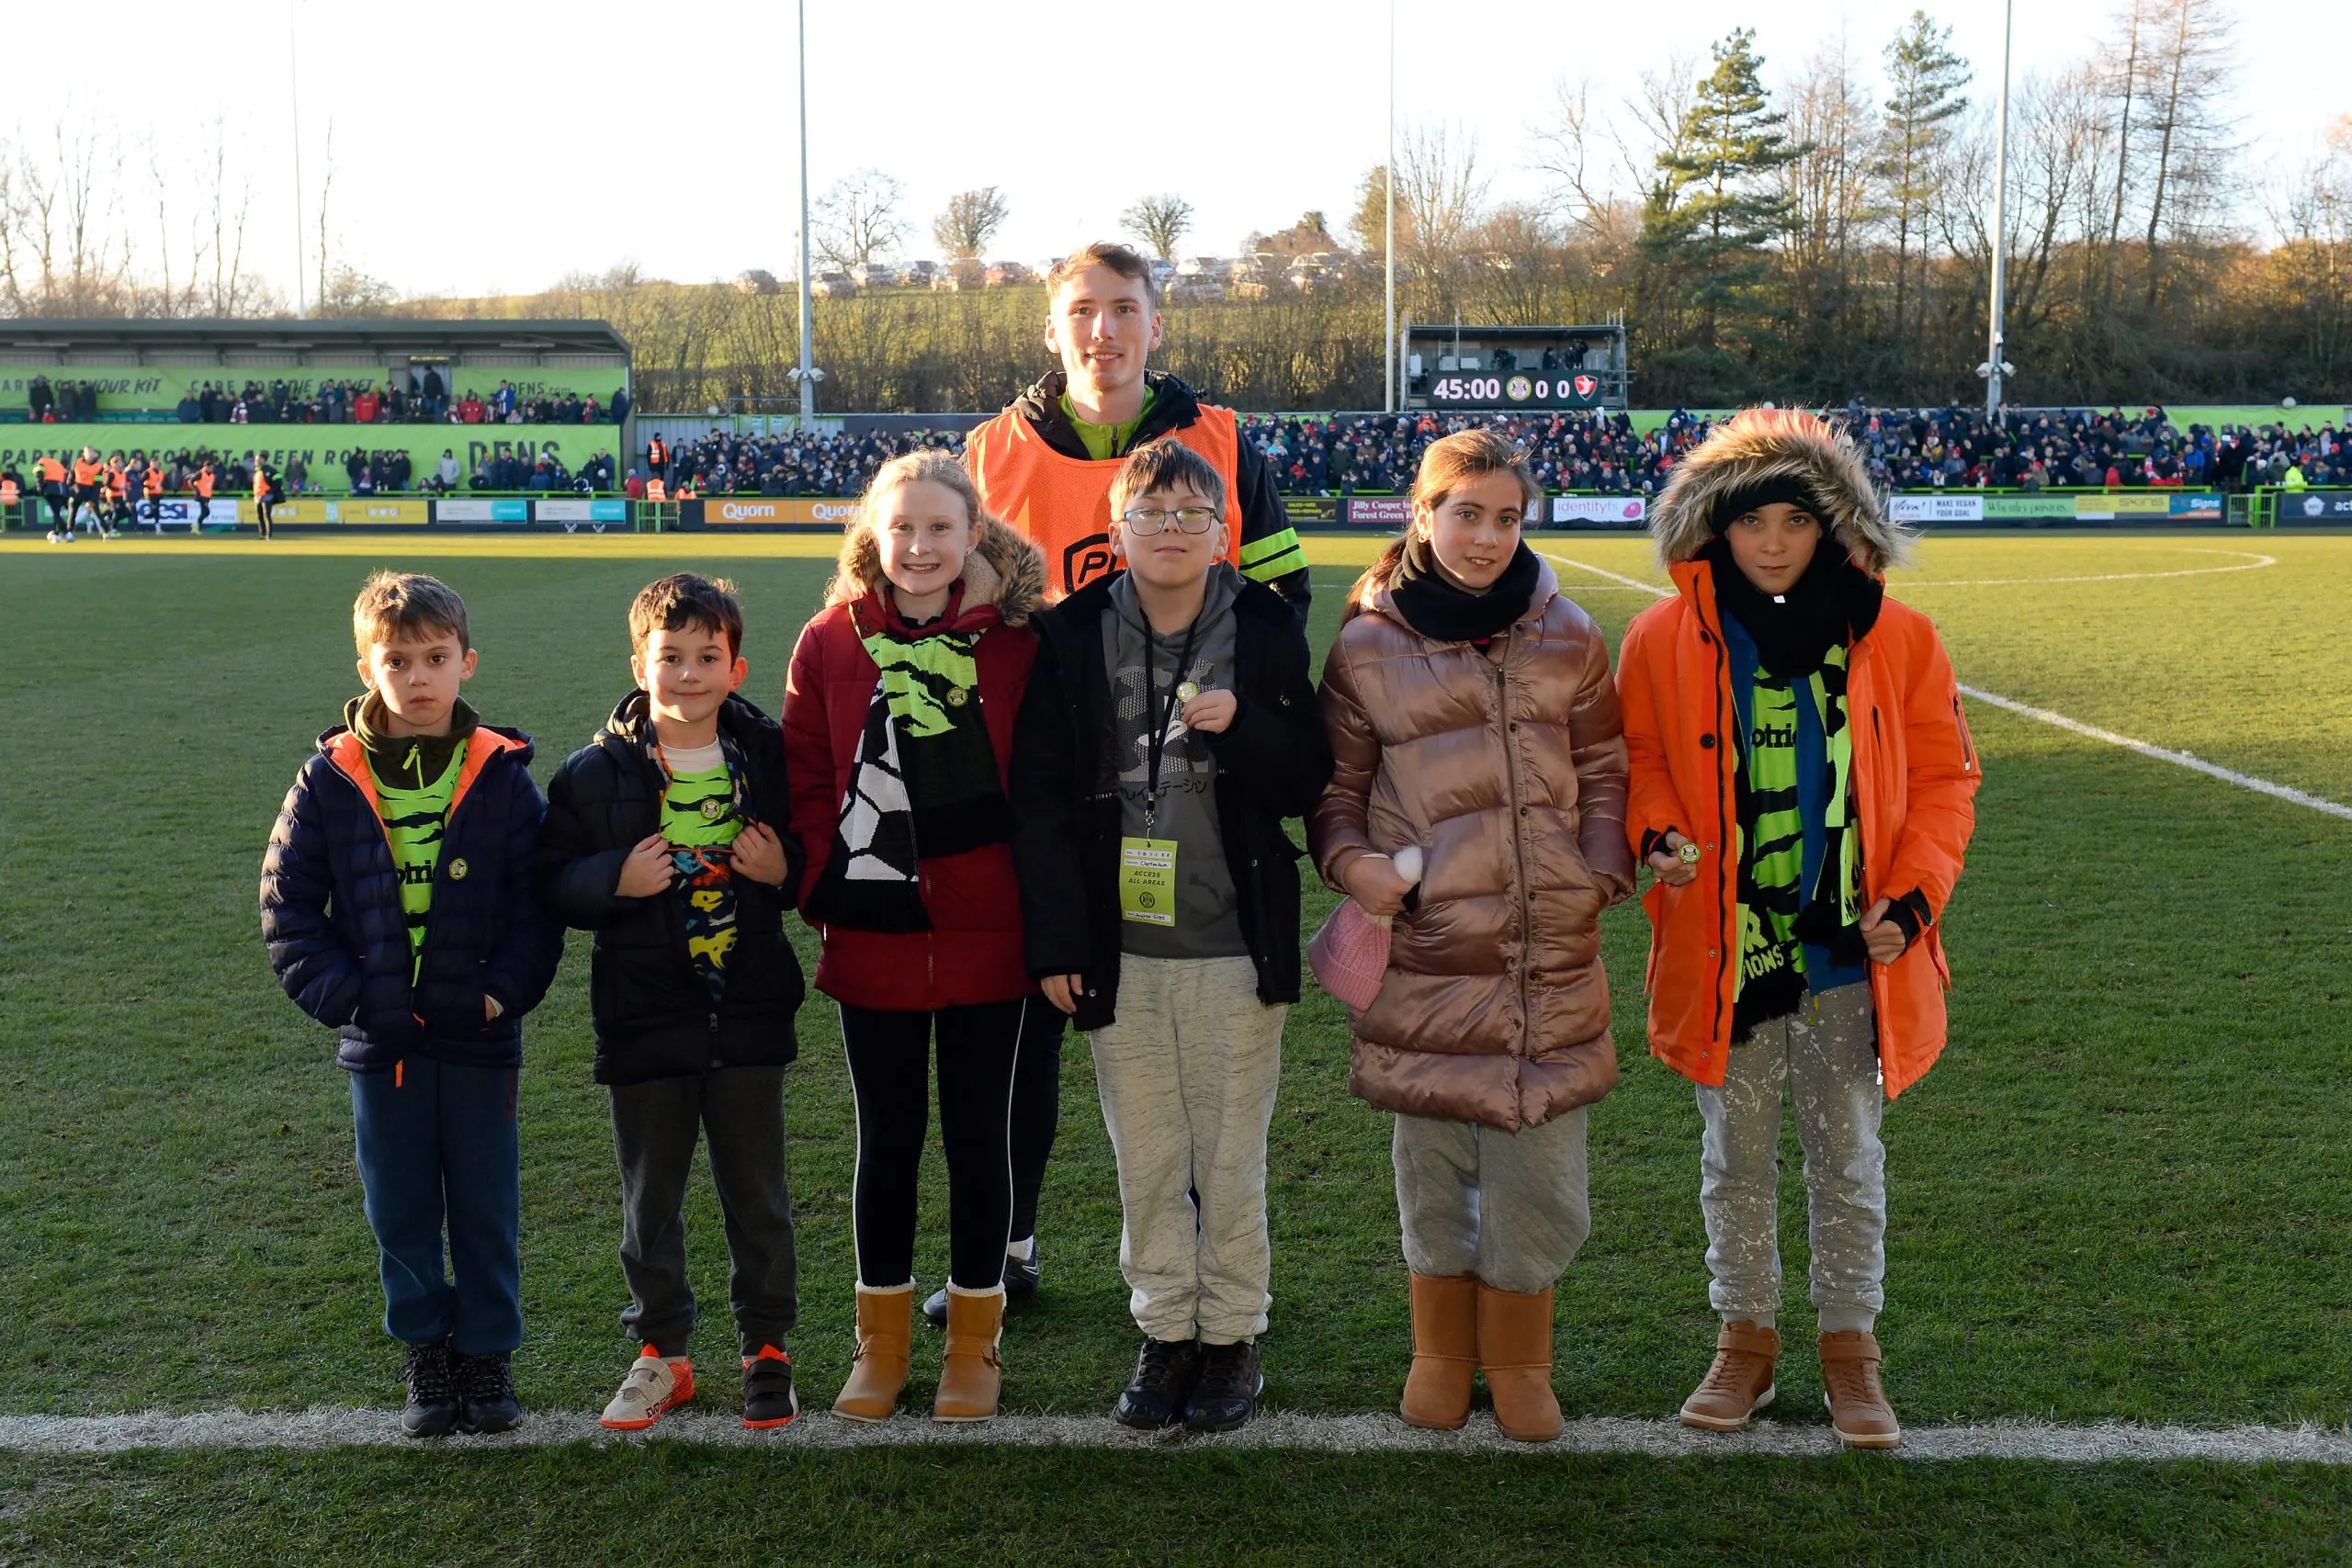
[538,571,802,1432]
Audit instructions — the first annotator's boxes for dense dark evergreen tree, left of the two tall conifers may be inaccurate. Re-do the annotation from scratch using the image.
[1642,28,1806,371]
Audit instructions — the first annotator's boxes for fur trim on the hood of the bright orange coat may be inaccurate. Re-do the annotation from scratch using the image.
[1649,409,1910,576]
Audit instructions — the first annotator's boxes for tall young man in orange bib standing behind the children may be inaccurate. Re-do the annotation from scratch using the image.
[955,243,1307,1325]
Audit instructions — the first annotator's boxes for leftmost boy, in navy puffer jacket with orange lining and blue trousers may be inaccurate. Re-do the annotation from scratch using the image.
[261,571,564,1437]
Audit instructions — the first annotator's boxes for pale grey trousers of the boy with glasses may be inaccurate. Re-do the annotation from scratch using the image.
[1089,954,1289,1345]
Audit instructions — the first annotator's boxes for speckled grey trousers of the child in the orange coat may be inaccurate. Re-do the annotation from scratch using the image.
[1698,985,1886,1333]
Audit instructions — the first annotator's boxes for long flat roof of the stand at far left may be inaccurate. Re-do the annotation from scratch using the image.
[0,317,628,365]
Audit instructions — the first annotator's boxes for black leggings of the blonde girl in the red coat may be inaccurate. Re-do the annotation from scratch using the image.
[842,999,1045,1291]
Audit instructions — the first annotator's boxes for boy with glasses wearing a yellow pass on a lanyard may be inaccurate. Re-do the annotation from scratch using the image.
[1012,440,1331,1432]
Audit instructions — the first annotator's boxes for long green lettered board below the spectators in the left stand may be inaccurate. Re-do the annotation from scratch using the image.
[0,425,623,493]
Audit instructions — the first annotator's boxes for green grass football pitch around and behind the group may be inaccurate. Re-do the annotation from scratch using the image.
[0,531,2352,1563]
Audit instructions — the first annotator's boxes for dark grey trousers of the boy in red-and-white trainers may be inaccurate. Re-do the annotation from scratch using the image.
[612,1067,799,1357]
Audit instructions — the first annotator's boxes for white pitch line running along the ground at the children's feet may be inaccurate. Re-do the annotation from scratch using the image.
[0,1408,2352,1464]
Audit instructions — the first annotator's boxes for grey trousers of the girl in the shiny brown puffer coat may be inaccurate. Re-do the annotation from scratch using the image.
[1390,1105,1592,1295]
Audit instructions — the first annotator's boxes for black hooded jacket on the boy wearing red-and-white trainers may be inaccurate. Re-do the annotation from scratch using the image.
[538,691,802,1084]
